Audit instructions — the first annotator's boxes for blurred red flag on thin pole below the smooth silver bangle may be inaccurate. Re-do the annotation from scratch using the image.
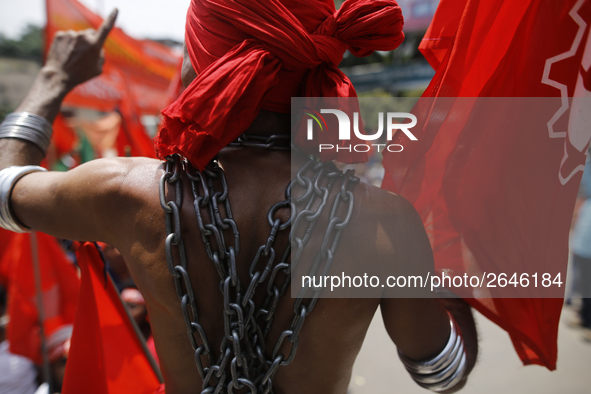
[2,233,80,364]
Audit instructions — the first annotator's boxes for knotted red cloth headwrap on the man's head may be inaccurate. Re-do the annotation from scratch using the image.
[154,0,404,169]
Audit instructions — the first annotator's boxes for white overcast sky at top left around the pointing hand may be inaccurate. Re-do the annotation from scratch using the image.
[0,0,190,41]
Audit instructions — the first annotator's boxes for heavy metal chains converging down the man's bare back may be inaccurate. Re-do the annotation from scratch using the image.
[160,155,359,394]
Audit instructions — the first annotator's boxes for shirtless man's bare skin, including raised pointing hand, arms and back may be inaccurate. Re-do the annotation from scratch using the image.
[0,3,477,394]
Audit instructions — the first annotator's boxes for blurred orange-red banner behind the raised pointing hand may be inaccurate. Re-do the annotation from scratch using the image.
[46,0,180,115]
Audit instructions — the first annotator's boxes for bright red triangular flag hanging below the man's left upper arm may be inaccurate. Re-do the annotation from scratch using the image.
[62,243,160,394]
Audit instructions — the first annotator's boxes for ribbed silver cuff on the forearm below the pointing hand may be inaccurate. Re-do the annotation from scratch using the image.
[0,112,53,154]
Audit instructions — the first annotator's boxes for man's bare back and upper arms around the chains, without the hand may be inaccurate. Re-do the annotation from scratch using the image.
[6,143,472,393]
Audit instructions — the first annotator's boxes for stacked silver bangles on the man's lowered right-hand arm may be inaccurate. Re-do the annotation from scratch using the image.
[398,313,467,393]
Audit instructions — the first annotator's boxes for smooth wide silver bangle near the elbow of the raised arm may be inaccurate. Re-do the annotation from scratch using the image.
[0,166,47,233]
